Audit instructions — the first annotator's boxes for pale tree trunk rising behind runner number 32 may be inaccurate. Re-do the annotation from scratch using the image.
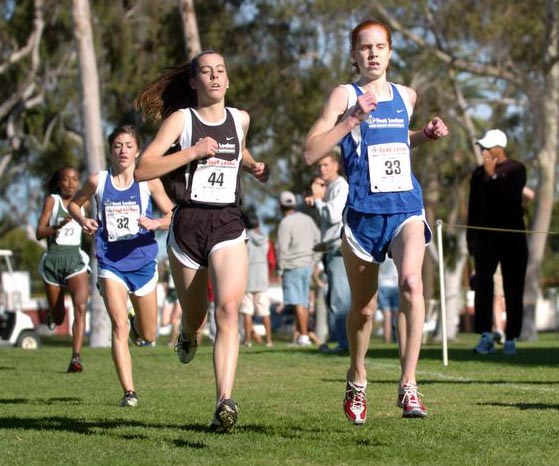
[72,0,111,347]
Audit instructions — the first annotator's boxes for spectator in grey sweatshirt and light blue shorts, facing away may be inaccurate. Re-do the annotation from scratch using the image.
[276,191,320,346]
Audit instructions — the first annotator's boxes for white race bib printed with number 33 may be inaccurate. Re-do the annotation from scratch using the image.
[367,142,413,193]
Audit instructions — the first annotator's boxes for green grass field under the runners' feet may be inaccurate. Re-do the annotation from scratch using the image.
[0,333,559,466]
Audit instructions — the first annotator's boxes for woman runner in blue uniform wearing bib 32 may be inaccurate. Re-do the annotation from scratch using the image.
[69,125,173,407]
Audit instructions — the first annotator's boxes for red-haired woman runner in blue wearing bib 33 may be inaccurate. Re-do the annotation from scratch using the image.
[303,20,448,424]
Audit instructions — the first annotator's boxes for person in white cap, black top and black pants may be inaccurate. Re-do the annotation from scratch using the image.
[467,129,528,355]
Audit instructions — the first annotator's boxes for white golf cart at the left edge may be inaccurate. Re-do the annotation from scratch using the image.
[0,249,41,349]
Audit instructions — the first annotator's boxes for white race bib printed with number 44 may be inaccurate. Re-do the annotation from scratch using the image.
[190,157,239,204]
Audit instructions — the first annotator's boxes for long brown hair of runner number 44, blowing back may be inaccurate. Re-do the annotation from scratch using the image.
[134,50,225,121]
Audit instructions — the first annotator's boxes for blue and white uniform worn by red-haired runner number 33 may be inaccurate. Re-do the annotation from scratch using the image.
[340,83,431,263]
